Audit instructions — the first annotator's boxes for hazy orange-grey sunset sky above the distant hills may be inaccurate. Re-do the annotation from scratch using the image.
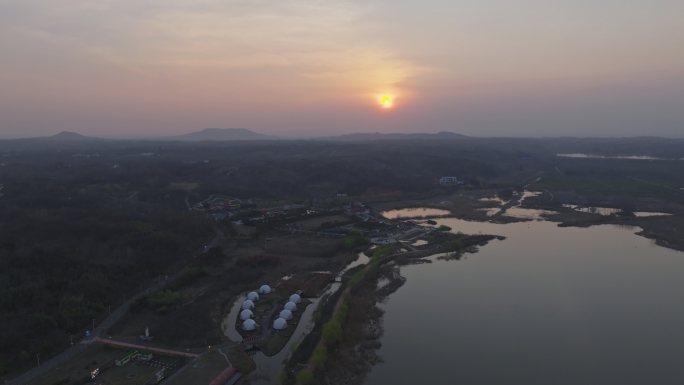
[0,0,684,138]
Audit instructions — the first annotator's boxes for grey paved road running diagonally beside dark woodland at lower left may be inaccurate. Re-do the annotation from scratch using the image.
[5,229,223,385]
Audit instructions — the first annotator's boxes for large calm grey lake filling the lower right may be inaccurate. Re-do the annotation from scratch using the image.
[366,214,684,385]
